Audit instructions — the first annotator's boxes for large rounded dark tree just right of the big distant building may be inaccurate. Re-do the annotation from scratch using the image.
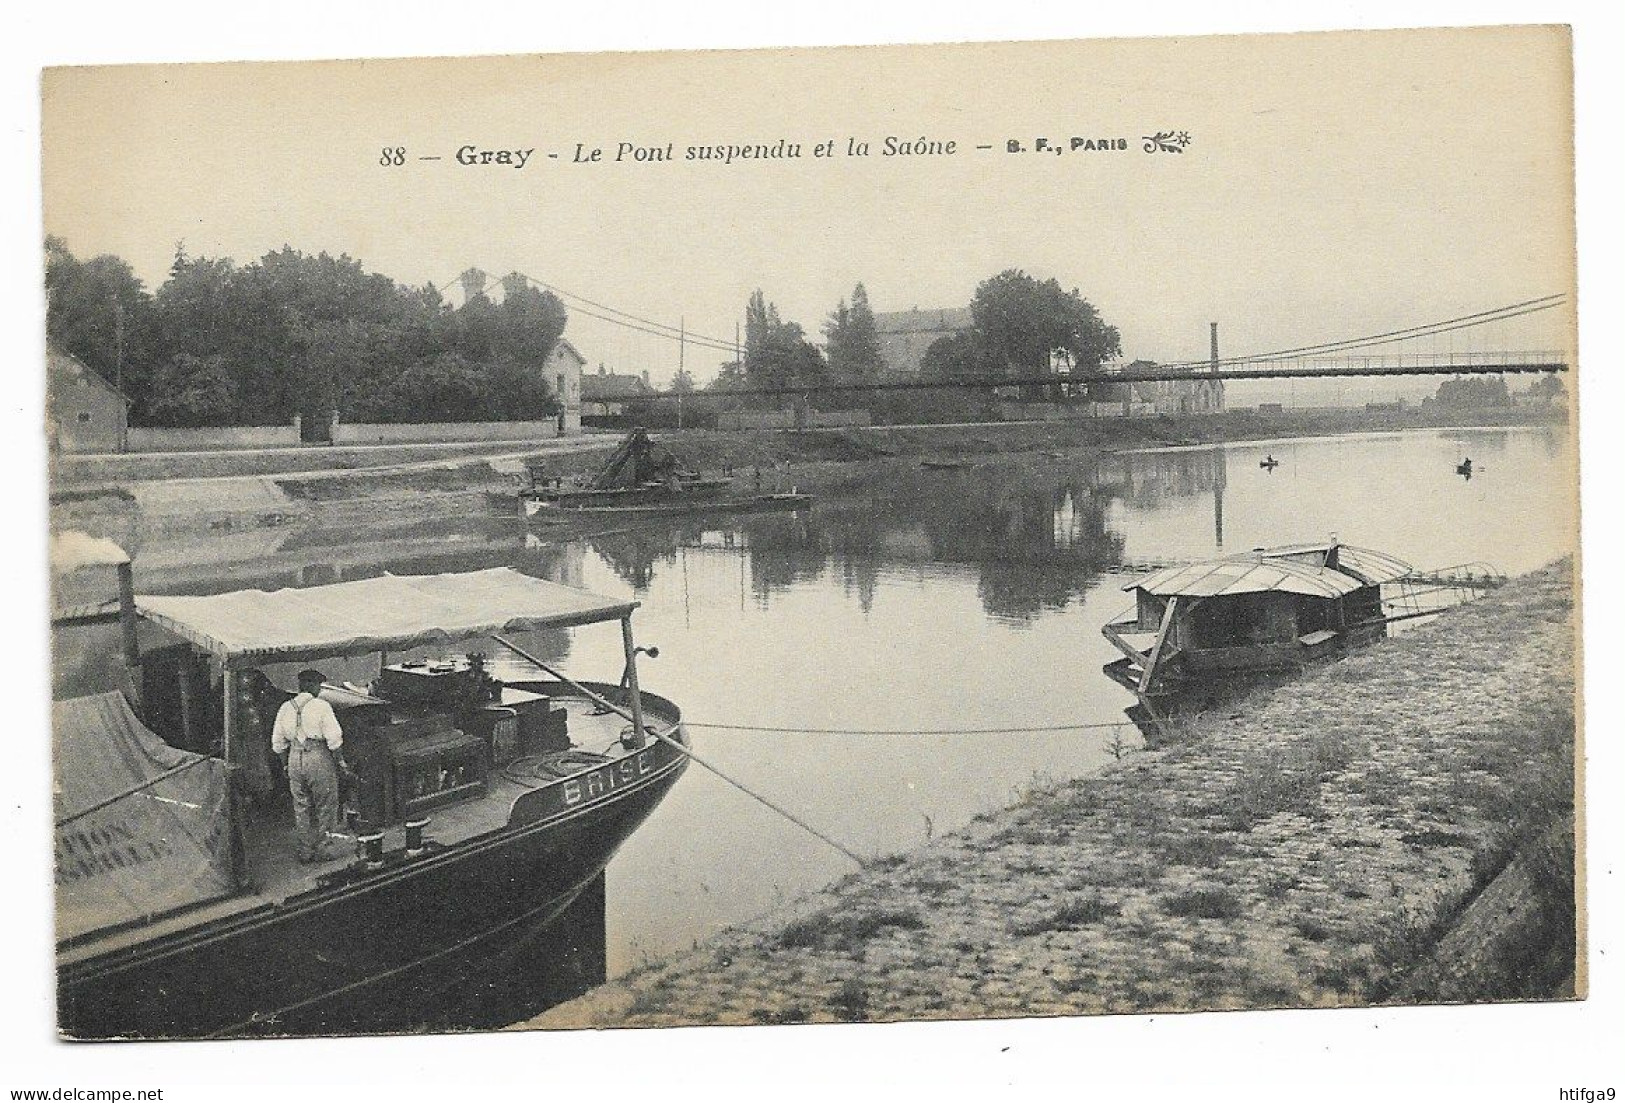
[970,268,1121,375]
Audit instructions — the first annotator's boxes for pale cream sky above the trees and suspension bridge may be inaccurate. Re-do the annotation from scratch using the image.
[42,28,1573,396]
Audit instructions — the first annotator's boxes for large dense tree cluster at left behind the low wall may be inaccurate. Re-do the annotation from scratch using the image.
[46,239,566,426]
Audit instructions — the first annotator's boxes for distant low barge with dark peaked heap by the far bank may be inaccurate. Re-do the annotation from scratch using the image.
[501,429,813,520]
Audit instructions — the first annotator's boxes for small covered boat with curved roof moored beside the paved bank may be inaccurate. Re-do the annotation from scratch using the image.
[1102,541,1412,703]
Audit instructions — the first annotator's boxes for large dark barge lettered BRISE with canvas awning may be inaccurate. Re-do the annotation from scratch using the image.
[54,538,687,1038]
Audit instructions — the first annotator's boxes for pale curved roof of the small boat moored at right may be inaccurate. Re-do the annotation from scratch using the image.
[1123,544,1411,598]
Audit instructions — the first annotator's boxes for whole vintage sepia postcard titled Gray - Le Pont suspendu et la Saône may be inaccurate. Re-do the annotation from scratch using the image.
[42,26,1588,1059]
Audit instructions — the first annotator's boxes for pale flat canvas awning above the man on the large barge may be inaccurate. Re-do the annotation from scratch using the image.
[135,567,637,663]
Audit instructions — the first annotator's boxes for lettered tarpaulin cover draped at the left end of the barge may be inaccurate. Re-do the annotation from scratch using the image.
[52,694,234,939]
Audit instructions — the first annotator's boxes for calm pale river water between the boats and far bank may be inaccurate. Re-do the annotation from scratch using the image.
[59,429,1576,975]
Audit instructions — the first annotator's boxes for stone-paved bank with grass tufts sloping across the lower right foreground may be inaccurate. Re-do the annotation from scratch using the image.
[531,564,1575,1027]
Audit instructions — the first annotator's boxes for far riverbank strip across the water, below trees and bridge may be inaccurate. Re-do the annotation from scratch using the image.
[52,406,1563,530]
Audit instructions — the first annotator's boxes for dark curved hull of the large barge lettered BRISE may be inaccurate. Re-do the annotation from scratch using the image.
[59,746,687,1040]
